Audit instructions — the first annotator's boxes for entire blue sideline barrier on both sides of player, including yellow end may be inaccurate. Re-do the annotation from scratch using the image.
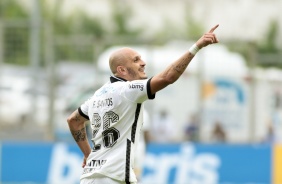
[0,142,282,184]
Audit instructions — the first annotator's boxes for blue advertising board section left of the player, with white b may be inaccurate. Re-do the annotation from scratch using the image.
[0,142,83,184]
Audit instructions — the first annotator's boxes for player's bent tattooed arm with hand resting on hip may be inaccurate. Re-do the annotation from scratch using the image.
[67,110,91,167]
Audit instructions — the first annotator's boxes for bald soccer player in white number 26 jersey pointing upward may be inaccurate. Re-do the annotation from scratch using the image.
[67,25,218,184]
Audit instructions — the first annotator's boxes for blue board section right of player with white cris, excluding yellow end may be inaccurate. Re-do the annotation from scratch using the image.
[142,144,271,184]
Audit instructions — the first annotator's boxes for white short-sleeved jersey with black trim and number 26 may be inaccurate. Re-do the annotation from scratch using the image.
[78,77,155,183]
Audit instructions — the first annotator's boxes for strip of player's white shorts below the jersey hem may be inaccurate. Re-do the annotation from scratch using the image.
[80,174,136,184]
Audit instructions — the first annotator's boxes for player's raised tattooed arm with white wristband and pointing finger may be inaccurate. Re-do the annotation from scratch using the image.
[150,25,219,94]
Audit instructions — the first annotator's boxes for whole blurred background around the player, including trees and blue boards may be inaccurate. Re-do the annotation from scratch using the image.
[0,0,282,184]
